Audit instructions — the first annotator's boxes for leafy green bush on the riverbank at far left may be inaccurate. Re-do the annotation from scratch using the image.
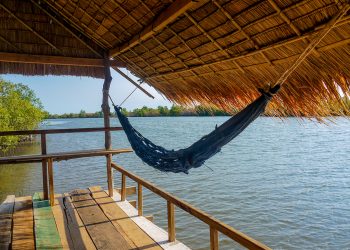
[0,78,45,152]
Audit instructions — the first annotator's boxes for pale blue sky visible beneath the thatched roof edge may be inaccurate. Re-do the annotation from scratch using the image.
[0,69,171,114]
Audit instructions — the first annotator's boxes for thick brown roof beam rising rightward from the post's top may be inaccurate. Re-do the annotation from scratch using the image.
[110,0,193,57]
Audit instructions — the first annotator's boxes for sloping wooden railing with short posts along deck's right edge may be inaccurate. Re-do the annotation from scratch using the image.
[112,162,270,250]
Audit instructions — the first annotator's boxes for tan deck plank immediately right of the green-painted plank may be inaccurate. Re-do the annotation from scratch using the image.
[51,194,74,249]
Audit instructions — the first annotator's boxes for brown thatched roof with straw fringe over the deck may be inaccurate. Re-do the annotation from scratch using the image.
[0,0,350,116]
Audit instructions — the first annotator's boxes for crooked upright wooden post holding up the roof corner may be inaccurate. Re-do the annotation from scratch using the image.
[102,53,113,197]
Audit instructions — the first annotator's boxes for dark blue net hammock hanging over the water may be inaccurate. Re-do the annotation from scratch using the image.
[114,85,280,174]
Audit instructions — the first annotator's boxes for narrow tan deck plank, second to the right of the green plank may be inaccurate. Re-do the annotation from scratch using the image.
[63,193,96,250]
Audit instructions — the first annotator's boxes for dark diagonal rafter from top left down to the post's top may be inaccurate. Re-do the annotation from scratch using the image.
[30,0,103,58]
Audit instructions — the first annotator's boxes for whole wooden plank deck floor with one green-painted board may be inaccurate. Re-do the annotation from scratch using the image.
[0,187,189,250]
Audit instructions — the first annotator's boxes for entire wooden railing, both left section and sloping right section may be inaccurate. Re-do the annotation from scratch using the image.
[0,127,270,250]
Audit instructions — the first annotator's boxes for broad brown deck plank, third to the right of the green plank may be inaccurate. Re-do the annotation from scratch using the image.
[71,190,130,250]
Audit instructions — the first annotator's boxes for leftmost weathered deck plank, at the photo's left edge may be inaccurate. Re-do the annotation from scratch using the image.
[0,195,15,249]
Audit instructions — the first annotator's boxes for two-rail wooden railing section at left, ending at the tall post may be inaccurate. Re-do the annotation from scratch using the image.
[0,127,123,199]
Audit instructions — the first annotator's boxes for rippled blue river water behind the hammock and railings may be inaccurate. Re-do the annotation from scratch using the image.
[0,117,350,249]
